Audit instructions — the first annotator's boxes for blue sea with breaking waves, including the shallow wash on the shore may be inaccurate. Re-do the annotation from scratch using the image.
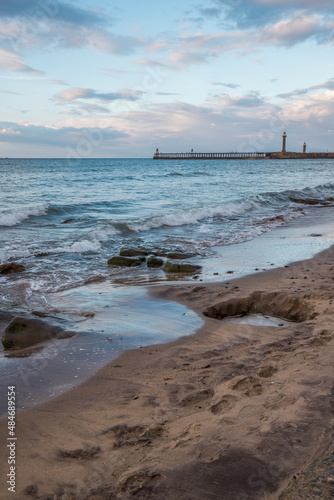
[0,159,334,408]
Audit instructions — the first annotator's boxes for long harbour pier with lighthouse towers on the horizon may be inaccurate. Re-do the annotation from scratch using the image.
[153,132,334,160]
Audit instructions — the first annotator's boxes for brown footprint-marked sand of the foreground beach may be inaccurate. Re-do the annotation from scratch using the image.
[0,247,334,500]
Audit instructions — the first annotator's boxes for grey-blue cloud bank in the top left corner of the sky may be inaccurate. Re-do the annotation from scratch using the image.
[0,5,149,55]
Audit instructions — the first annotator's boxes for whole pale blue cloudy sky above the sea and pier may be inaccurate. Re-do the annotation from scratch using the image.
[0,0,334,158]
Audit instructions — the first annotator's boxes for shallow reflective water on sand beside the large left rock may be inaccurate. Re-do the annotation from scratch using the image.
[0,282,203,415]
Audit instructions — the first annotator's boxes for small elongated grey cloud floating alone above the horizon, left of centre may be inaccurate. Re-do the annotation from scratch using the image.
[54,87,144,104]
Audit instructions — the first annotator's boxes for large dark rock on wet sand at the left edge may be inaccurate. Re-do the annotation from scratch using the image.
[2,316,76,349]
